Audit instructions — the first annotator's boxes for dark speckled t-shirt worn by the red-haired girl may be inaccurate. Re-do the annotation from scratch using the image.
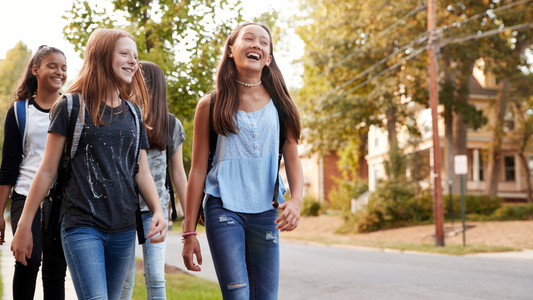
[48,99,149,233]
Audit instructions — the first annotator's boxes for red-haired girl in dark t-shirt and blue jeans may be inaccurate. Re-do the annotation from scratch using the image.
[11,29,167,299]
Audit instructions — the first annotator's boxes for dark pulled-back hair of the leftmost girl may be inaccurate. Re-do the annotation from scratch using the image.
[10,45,66,106]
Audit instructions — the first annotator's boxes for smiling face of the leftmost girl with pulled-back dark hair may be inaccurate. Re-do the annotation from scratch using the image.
[32,52,67,91]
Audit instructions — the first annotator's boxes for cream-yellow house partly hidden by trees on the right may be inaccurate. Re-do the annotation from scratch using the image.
[366,60,533,201]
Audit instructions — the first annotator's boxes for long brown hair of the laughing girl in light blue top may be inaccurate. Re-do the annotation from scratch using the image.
[213,23,300,141]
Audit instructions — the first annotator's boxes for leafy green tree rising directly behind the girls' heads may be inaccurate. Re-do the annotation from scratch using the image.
[63,0,242,170]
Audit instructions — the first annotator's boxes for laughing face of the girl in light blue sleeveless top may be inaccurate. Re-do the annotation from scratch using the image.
[228,25,272,72]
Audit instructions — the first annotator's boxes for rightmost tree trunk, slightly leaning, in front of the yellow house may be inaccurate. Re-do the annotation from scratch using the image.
[485,79,510,196]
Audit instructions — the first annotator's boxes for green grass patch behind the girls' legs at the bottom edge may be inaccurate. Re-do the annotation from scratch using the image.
[132,273,222,300]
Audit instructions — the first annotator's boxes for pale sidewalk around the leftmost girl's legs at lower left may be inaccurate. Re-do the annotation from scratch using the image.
[0,222,77,300]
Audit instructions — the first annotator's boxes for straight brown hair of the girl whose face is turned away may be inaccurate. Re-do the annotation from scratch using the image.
[139,61,169,151]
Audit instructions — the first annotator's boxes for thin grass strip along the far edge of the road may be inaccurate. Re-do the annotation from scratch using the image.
[282,237,520,255]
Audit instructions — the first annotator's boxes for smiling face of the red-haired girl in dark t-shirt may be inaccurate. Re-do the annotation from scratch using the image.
[113,37,139,84]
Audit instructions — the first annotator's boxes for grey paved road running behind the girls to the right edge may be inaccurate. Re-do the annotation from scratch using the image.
[143,234,533,300]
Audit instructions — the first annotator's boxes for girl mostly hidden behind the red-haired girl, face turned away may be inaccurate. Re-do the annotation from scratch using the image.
[121,61,187,300]
